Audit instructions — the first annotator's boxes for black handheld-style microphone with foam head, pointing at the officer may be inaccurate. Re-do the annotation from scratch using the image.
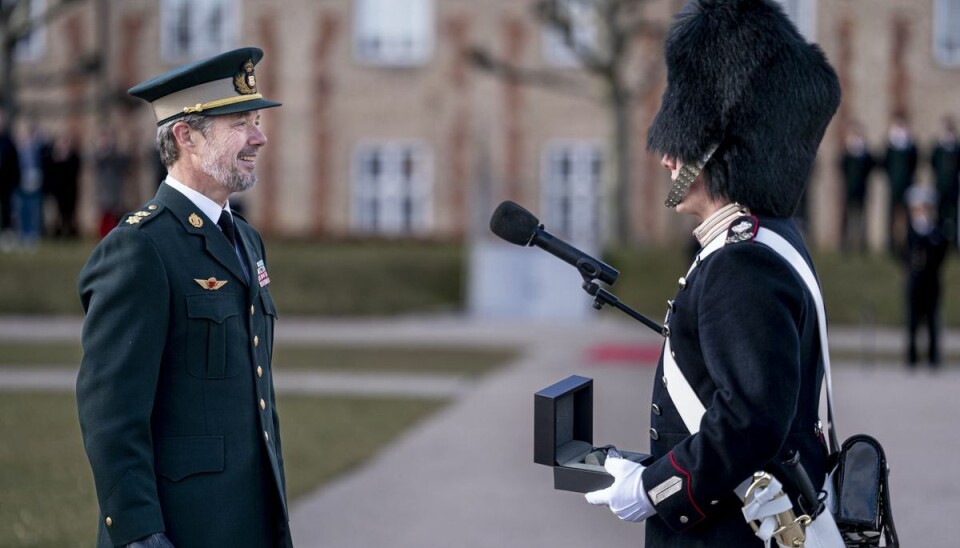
[490,200,620,285]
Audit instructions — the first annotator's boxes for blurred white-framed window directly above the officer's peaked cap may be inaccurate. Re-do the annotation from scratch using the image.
[160,0,239,63]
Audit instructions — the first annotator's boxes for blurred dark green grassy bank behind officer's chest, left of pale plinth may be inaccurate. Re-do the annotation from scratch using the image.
[0,240,464,317]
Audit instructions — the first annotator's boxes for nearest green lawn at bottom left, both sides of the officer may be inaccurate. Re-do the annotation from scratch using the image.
[0,393,443,548]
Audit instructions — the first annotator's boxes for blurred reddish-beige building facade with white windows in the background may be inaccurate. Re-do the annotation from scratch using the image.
[16,0,960,249]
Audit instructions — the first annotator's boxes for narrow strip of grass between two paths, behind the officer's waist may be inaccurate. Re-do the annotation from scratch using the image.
[0,340,516,377]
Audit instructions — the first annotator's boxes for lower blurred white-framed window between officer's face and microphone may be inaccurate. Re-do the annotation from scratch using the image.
[352,142,433,236]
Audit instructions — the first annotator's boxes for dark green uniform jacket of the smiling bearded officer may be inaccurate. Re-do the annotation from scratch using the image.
[77,184,289,548]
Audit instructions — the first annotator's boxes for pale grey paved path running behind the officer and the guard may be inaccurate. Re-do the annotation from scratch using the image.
[0,315,960,548]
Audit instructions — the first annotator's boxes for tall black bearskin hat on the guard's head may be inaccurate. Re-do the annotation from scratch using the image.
[647,0,840,217]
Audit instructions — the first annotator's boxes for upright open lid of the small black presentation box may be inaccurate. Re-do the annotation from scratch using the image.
[533,375,593,466]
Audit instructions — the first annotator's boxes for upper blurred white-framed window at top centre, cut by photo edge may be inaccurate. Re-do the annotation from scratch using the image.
[353,0,435,66]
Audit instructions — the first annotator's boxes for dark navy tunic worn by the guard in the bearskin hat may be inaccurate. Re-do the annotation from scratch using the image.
[643,217,826,548]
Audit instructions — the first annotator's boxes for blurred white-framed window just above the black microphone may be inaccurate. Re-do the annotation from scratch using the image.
[541,141,603,244]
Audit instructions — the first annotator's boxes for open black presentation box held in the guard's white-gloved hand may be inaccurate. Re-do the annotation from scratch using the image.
[533,375,649,493]
